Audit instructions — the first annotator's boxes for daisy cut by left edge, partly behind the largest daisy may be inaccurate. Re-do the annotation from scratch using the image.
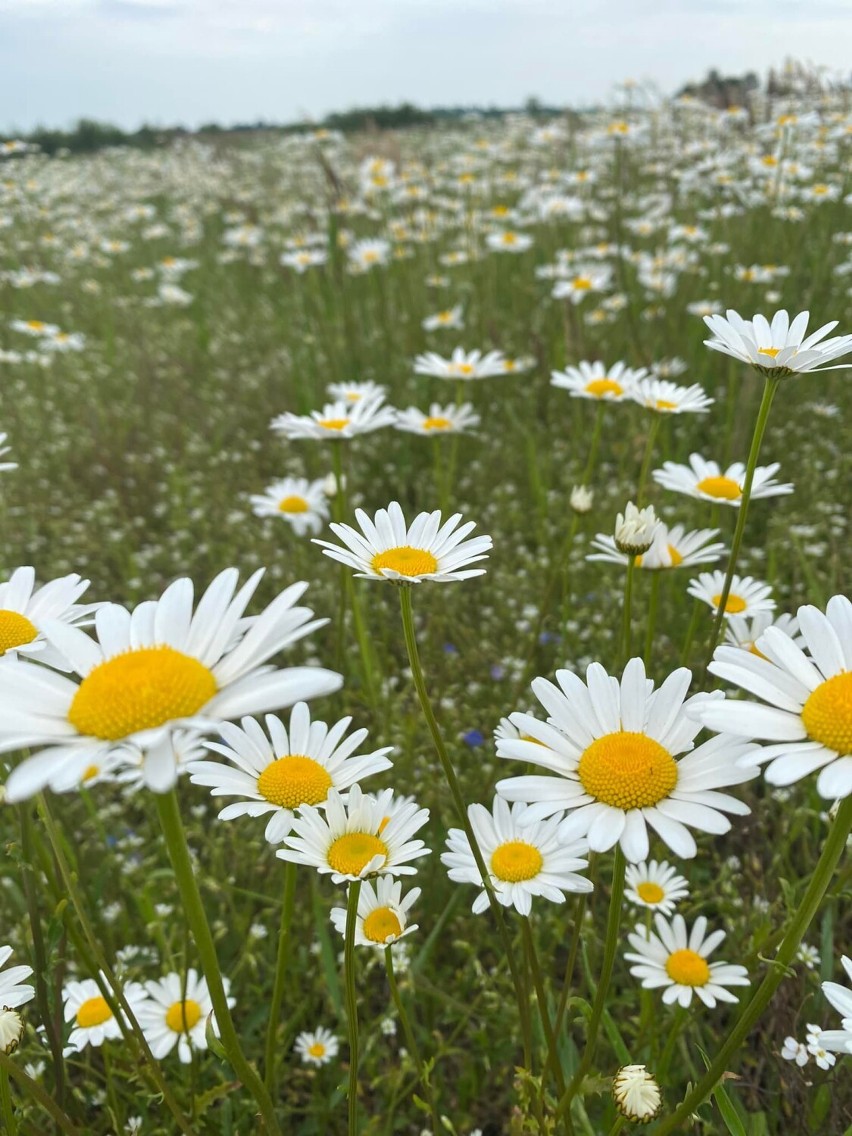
[0,567,99,667]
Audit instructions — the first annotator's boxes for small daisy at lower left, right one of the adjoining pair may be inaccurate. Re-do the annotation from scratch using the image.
[136,967,228,1064]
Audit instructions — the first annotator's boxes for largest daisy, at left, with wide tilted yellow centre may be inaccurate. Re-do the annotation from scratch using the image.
[0,568,342,801]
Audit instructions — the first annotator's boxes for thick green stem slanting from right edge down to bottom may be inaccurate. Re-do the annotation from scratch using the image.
[654,796,852,1136]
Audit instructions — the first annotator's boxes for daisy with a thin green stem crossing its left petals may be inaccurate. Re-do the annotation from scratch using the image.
[441,797,592,916]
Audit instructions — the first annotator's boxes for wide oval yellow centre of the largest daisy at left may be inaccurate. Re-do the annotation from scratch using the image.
[68,646,216,742]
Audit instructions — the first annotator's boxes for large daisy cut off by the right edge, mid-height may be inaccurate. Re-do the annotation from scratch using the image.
[700,595,852,800]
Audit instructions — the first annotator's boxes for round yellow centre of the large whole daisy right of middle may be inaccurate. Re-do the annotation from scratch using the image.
[577,729,677,810]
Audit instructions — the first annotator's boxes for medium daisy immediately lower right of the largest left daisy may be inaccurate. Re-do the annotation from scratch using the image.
[187,702,391,844]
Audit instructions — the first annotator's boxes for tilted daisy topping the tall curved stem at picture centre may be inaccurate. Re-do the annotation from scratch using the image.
[314,501,491,584]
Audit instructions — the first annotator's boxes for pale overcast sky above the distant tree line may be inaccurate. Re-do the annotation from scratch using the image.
[0,0,852,134]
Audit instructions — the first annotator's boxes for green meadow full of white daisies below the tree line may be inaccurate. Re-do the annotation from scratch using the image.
[0,69,852,1136]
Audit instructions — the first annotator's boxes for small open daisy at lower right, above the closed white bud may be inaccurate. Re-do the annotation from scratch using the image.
[625,914,749,1010]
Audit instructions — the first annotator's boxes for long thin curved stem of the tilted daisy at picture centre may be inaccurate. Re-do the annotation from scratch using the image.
[400,584,532,1069]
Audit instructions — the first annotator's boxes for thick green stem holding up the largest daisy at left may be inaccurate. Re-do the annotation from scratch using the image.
[154,788,281,1136]
